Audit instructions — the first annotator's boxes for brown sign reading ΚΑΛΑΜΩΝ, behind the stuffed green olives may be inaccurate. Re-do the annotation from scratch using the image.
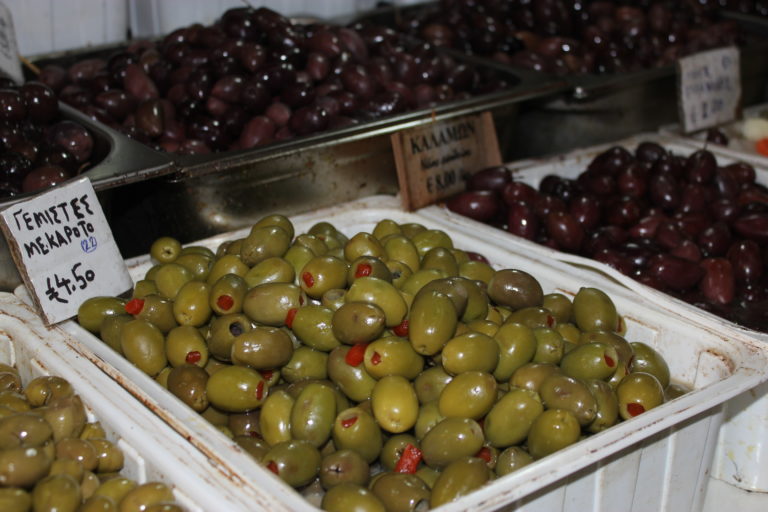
[391,112,501,210]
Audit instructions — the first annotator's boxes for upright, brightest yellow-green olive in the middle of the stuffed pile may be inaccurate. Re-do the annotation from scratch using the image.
[371,375,419,434]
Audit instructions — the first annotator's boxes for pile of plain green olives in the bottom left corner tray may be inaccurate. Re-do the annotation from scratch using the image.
[0,364,182,512]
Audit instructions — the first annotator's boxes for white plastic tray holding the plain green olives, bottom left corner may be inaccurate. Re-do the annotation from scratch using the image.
[0,292,260,512]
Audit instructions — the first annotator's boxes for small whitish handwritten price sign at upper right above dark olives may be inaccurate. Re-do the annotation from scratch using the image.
[677,47,741,133]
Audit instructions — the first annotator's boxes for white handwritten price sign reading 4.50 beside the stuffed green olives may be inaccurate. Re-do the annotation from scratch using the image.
[0,178,132,325]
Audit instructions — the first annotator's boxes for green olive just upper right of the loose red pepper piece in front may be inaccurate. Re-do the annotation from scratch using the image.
[421,418,484,469]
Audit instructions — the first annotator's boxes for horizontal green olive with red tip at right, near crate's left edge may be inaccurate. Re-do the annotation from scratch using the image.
[205,366,269,412]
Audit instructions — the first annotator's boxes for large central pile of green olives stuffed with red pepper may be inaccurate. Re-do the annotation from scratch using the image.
[78,215,682,511]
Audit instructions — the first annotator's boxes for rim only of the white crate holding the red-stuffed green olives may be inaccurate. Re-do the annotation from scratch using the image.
[22,197,768,512]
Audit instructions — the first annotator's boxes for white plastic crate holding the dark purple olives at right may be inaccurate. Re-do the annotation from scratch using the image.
[414,134,768,500]
